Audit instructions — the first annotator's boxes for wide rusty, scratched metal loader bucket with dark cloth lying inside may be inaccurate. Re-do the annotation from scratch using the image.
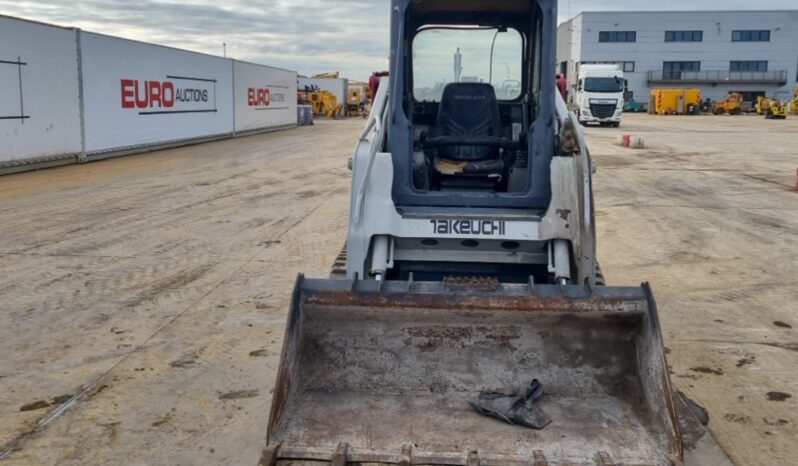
[261,276,682,466]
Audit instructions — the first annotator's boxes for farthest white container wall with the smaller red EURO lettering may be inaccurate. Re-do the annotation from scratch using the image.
[238,61,297,132]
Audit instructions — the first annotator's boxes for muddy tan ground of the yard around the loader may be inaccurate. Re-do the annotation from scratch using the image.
[0,115,798,466]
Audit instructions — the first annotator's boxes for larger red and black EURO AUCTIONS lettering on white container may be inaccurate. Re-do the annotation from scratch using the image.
[120,76,217,115]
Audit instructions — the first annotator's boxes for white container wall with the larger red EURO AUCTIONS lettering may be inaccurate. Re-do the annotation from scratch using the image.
[81,32,233,153]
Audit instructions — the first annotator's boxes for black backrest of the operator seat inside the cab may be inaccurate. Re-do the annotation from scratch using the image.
[434,83,501,160]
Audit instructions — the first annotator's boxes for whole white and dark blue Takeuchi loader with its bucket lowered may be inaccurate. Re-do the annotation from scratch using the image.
[260,0,708,466]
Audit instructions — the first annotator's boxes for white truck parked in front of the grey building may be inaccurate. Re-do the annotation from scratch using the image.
[575,65,626,128]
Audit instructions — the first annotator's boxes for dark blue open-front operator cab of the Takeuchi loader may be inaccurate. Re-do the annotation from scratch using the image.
[388,0,556,210]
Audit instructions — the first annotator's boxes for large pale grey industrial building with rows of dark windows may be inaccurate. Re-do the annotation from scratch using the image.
[557,10,798,101]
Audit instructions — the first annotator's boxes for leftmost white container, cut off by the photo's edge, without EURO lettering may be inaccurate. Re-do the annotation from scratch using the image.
[0,16,81,167]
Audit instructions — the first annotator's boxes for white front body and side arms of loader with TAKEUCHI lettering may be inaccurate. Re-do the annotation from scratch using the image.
[346,78,596,284]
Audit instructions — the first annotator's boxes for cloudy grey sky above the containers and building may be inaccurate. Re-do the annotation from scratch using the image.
[0,0,798,79]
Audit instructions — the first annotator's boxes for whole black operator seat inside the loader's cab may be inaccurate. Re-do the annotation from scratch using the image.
[423,83,515,188]
